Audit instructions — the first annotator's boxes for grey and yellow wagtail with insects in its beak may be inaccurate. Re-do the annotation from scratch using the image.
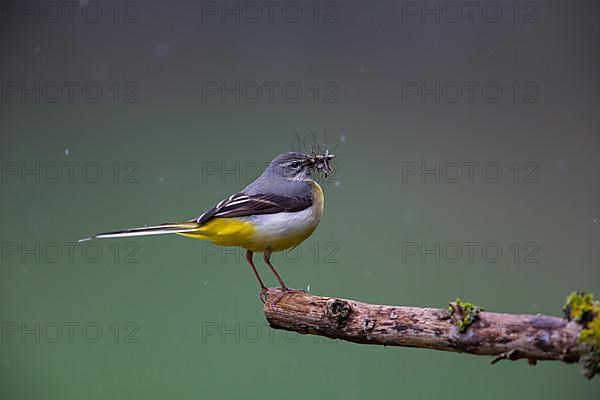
[80,152,334,300]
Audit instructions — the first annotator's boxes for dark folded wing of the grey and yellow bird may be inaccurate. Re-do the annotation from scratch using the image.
[194,192,313,224]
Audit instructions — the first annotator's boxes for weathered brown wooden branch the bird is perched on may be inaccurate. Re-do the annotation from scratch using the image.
[263,288,598,378]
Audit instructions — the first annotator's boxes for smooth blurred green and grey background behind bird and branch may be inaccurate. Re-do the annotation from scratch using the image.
[0,1,600,400]
